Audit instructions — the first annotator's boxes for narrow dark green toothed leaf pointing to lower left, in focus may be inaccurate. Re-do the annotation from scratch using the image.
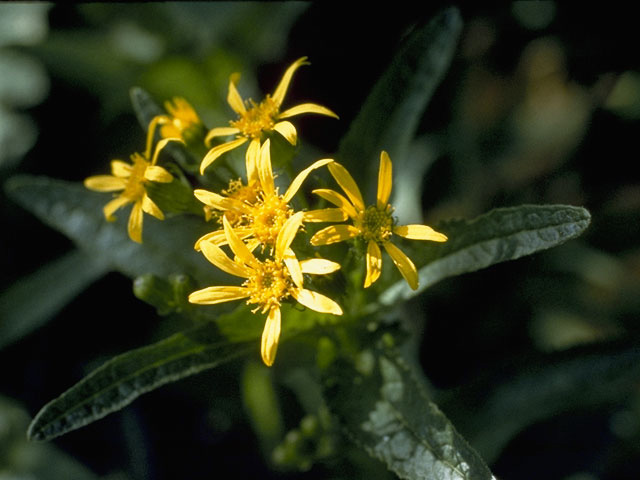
[27,316,259,440]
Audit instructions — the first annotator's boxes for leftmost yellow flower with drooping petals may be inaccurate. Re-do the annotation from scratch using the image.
[84,138,178,243]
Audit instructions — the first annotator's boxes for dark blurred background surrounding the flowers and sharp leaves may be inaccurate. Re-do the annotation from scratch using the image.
[0,1,640,480]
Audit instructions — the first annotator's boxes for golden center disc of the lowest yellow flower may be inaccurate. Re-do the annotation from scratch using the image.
[243,260,293,313]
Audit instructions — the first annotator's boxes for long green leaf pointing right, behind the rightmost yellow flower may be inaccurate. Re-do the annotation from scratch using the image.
[380,205,591,305]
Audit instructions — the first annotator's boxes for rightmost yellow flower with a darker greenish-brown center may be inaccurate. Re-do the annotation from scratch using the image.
[311,151,447,290]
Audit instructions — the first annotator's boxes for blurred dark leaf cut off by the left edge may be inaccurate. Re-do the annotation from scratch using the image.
[0,250,109,349]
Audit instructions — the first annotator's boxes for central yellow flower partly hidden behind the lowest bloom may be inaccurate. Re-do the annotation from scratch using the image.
[193,139,346,250]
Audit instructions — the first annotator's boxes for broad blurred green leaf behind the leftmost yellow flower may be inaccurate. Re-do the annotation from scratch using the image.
[6,176,225,285]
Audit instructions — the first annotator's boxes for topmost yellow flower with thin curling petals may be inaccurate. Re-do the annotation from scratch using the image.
[200,57,338,174]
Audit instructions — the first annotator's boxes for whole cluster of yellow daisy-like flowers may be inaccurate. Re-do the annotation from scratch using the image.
[85,57,447,366]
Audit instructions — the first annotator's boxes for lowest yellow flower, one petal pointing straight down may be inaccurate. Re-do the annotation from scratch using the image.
[189,212,342,366]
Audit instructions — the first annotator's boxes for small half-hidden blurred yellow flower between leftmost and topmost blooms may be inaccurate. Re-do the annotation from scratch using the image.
[149,97,204,142]
